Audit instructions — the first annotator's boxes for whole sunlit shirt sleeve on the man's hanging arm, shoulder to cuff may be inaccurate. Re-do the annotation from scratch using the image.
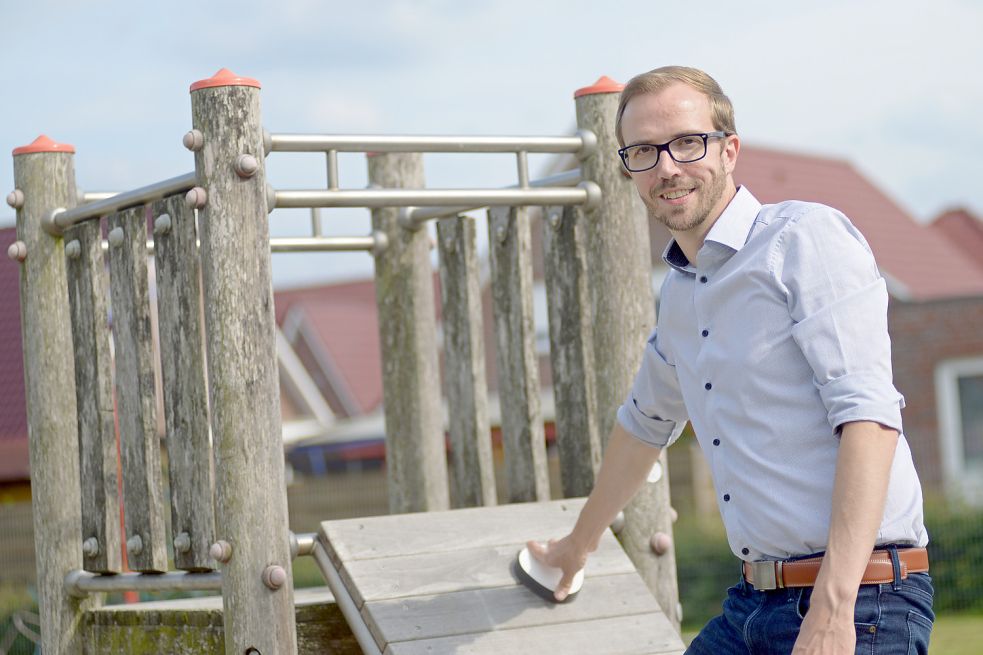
[774,208,904,432]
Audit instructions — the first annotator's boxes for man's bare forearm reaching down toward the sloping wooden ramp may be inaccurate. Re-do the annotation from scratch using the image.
[571,421,662,551]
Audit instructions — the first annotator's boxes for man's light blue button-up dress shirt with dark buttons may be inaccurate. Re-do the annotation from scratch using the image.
[618,187,928,561]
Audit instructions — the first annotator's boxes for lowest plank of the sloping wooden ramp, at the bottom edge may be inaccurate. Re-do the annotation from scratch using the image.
[385,614,685,655]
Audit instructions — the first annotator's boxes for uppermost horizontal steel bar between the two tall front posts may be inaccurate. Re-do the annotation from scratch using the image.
[271,133,597,153]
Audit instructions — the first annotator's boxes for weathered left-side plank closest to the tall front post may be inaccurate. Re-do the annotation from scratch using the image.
[152,197,215,571]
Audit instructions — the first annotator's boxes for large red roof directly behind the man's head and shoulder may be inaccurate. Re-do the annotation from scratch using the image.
[734,147,983,300]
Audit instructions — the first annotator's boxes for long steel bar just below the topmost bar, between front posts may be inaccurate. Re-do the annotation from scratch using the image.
[274,187,588,208]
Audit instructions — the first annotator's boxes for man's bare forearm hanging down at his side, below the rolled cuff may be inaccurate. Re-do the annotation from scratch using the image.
[813,421,898,617]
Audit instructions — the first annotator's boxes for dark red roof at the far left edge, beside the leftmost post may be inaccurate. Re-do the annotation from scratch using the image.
[0,227,30,480]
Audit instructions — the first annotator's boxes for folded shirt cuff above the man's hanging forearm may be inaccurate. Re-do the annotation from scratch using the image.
[819,373,904,432]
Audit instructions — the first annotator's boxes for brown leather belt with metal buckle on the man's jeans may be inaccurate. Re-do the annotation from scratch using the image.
[744,548,928,591]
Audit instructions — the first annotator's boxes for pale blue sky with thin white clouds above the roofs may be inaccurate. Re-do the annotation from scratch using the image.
[0,0,983,287]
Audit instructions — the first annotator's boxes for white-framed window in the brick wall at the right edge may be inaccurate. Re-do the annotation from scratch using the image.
[935,357,983,504]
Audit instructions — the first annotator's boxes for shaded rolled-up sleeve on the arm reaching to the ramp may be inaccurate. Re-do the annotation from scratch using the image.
[618,330,687,448]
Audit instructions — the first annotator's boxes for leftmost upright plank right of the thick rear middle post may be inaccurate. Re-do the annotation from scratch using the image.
[437,216,496,507]
